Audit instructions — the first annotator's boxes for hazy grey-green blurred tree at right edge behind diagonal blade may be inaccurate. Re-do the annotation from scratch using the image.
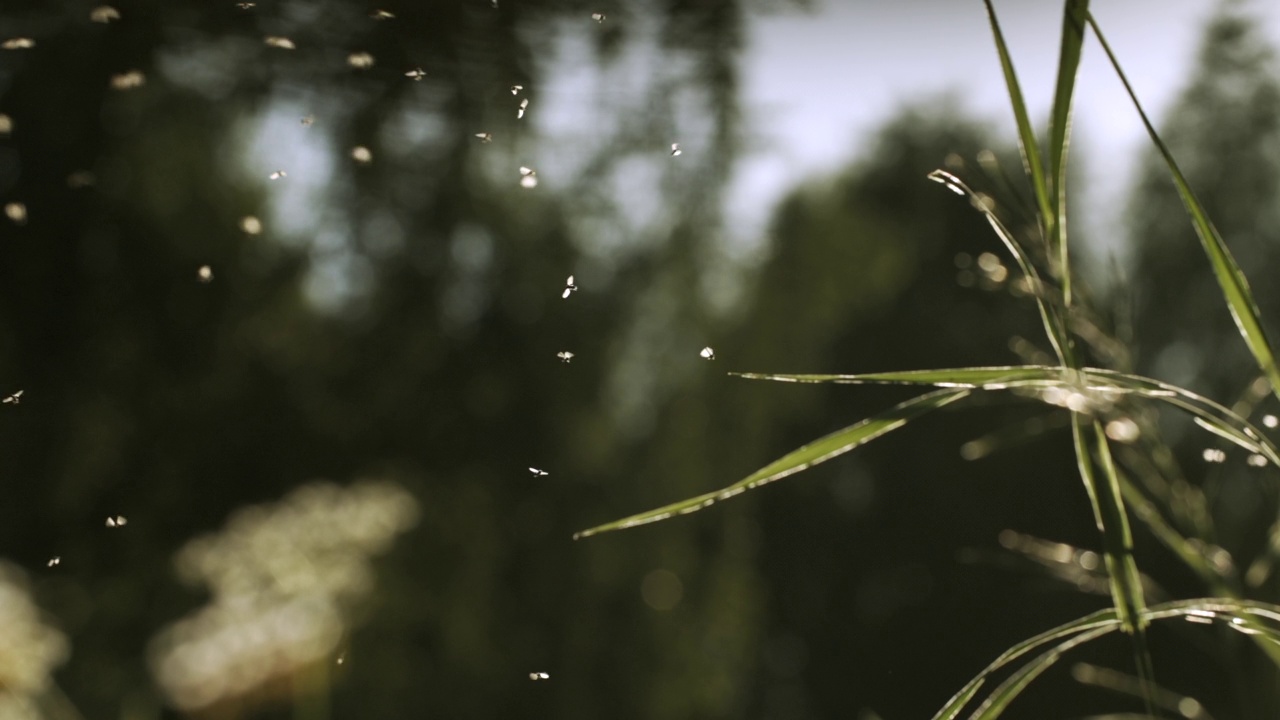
[1129,3,1280,401]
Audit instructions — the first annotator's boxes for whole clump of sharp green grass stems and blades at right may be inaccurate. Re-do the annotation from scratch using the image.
[577,0,1280,720]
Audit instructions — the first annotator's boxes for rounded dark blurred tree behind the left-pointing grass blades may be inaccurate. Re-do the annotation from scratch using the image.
[714,99,1105,719]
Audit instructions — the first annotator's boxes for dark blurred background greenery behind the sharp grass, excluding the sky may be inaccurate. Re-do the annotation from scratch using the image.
[0,0,1280,719]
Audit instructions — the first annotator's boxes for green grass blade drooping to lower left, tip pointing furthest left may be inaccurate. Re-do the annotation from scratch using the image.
[573,388,970,539]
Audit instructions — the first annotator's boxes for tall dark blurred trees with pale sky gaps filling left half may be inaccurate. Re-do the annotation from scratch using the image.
[0,0,756,719]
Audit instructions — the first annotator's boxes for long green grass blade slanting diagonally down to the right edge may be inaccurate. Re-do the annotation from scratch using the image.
[1088,14,1280,397]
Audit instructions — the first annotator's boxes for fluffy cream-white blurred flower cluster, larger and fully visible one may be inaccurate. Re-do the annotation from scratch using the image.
[150,483,417,711]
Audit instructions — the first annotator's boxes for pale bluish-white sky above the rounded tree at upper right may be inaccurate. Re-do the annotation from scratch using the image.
[730,0,1280,256]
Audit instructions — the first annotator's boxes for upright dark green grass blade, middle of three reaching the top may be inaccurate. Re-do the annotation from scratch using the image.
[1048,0,1089,307]
